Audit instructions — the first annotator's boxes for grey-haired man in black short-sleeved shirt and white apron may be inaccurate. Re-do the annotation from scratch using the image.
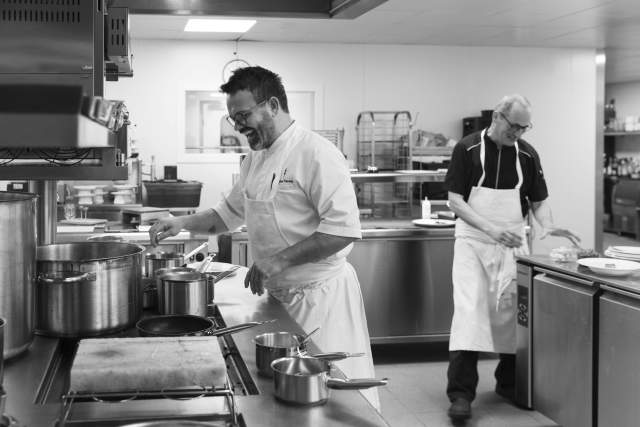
[445,95,579,420]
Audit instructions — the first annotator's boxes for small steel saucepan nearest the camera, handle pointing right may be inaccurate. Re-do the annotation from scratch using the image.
[271,356,388,406]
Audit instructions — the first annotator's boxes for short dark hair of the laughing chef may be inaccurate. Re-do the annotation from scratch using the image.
[220,67,289,113]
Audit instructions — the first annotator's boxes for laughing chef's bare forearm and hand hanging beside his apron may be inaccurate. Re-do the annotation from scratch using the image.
[244,231,357,295]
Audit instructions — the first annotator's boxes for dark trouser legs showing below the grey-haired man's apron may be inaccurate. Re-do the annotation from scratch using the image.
[447,351,516,402]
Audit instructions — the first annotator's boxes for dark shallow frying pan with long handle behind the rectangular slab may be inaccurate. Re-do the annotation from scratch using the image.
[136,314,275,337]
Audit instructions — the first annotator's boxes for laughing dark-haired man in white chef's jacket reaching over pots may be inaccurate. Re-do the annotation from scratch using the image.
[149,67,379,410]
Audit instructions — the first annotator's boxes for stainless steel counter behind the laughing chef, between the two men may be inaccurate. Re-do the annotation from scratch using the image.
[225,219,454,344]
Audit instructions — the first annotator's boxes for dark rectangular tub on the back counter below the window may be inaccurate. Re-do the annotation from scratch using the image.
[143,181,202,208]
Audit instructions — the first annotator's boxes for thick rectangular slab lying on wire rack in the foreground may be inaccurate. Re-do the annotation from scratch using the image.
[69,337,227,393]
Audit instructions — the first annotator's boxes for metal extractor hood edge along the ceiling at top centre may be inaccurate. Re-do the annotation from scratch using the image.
[108,0,387,19]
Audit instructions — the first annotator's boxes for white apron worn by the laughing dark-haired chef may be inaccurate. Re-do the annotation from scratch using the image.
[243,142,380,411]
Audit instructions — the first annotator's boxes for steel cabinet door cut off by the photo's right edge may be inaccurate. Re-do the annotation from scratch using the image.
[598,286,640,427]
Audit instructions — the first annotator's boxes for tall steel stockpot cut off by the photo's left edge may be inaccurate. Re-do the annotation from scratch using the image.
[0,192,38,358]
